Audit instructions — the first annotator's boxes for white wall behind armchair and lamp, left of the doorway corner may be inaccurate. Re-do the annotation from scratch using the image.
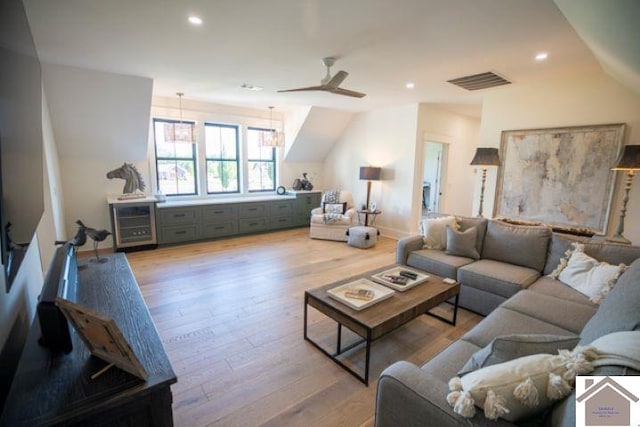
[322,104,422,236]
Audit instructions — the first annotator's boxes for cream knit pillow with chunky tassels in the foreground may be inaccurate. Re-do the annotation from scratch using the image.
[447,347,597,422]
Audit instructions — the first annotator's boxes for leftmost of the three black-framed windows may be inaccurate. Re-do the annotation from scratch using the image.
[153,119,197,196]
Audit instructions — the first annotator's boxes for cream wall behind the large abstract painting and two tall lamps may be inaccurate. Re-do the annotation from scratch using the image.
[474,74,640,244]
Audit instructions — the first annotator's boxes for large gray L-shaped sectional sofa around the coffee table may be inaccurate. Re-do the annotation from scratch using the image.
[375,218,640,427]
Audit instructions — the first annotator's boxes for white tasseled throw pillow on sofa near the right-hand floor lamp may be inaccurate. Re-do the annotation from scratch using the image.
[558,245,626,304]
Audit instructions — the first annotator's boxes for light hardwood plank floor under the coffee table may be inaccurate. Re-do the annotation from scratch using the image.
[127,228,480,427]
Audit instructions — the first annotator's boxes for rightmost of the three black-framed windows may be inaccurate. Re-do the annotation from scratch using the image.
[247,127,276,191]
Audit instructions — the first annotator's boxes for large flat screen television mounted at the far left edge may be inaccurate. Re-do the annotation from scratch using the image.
[0,0,44,292]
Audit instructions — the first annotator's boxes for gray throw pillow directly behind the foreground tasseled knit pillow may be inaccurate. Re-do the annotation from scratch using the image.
[458,334,580,376]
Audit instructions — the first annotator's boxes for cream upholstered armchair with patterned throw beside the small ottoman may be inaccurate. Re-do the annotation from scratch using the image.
[309,190,358,242]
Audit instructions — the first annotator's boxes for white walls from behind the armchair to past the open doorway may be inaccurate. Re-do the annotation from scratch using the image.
[322,104,480,238]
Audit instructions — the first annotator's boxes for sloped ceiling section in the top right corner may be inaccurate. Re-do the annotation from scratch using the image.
[555,0,640,94]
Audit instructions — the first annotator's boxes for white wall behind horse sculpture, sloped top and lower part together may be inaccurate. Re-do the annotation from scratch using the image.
[42,63,153,250]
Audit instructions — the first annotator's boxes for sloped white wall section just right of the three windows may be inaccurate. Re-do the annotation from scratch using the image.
[284,107,354,162]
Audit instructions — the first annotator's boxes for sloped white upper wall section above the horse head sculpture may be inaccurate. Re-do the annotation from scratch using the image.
[42,63,153,162]
